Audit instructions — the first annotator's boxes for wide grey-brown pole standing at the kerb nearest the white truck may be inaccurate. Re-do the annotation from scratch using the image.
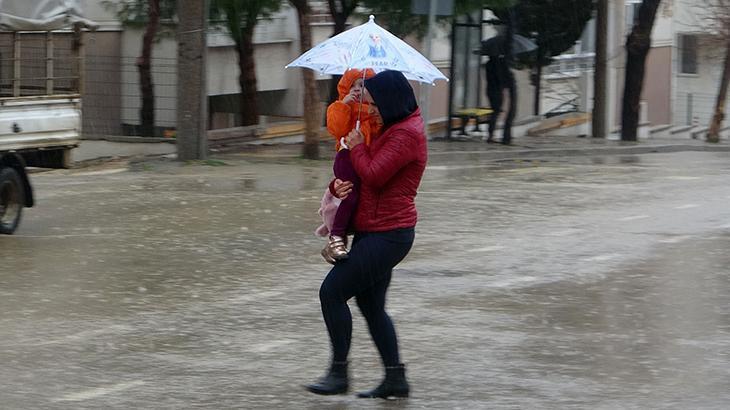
[177,0,208,161]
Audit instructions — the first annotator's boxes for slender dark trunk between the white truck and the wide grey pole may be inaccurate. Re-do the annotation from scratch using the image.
[137,0,160,137]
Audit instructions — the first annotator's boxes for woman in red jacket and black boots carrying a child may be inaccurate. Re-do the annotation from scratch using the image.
[307,71,427,398]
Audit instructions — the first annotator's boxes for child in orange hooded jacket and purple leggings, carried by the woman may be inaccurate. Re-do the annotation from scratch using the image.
[316,69,379,264]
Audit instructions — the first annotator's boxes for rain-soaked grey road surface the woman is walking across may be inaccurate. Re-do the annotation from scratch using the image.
[0,142,730,409]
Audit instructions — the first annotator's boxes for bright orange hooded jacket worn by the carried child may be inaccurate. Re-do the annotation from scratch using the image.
[327,69,380,150]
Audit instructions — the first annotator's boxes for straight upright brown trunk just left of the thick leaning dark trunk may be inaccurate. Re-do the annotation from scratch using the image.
[592,0,608,138]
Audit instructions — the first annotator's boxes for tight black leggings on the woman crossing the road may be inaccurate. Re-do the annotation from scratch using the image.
[319,228,415,366]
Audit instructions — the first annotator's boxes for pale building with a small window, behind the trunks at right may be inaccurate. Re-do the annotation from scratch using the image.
[542,0,730,138]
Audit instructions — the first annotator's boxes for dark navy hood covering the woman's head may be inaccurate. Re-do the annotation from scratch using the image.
[365,71,418,129]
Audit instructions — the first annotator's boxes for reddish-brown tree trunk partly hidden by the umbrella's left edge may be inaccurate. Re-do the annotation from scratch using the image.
[290,0,322,159]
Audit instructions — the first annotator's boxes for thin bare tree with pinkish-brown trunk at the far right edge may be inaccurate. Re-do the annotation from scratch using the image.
[705,0,730,142]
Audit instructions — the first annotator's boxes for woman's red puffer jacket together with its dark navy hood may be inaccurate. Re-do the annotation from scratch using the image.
[350,71,428,232]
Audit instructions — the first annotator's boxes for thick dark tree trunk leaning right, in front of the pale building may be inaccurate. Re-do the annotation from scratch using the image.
[621,0,661,141]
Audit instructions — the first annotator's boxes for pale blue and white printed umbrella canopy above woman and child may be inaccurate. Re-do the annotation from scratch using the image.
[286,16,448,84]
